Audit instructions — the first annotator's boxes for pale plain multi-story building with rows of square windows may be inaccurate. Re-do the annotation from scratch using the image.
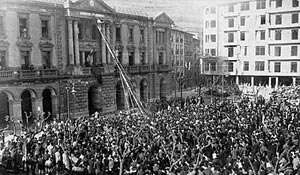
[202,0,300,87]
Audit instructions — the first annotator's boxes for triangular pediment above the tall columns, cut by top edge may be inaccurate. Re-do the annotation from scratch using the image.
[72,0,114,13]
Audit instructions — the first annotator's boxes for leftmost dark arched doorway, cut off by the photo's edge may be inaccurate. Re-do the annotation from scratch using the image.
[0,92,9,129]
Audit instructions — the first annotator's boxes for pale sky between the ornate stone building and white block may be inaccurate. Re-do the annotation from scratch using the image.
[104,0,236,32]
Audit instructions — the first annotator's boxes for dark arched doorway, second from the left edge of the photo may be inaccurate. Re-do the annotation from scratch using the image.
[21,90,33,126]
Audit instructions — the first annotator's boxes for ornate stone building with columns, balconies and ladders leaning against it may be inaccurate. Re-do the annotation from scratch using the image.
[0,0,173,129]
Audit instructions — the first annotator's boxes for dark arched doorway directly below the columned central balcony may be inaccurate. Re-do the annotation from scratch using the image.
[88,85,102,115]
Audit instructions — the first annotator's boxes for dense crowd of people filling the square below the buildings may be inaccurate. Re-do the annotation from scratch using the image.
[0,85,300,175]
